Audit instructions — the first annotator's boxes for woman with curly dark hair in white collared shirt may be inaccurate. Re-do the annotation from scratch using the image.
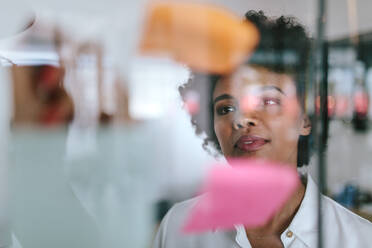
[154,11,372,248]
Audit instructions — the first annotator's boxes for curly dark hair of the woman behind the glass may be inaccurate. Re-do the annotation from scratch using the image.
[178,11,311,167]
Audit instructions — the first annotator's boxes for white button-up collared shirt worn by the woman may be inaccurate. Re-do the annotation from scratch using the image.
[153,176,372,248]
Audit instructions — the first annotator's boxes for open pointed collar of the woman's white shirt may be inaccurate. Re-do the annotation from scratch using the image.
[235,175,318,248]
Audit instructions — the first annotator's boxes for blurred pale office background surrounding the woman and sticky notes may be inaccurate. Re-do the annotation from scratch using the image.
[0,0,372,248]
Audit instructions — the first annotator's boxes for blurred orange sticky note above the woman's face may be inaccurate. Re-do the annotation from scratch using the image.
[140,0,259,74]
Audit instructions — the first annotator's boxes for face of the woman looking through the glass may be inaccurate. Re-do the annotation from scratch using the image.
[213,66,311,166]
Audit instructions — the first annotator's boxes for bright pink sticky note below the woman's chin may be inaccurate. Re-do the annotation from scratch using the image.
[183,160,299,232]
